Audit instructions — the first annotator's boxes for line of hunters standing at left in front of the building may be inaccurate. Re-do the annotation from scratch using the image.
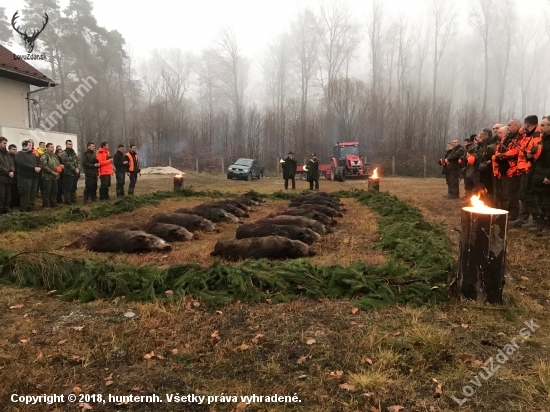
[0,136,141,214]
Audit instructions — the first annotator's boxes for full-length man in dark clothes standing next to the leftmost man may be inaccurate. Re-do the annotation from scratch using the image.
[15,140,42,212]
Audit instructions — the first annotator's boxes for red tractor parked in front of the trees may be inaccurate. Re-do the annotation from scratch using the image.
[330,142,370,182]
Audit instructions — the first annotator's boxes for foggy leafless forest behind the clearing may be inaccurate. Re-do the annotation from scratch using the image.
[0,0,550,175]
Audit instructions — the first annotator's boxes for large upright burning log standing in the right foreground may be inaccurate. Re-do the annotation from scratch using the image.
[455,207,508,303]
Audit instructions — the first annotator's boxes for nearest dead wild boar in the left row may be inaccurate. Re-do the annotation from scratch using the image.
[63,229,172,253]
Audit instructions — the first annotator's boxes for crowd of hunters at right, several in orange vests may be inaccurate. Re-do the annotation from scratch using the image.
[439,115,550,236]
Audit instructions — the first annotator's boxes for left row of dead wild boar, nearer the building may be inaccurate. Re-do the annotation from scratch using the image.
[63,195,265,253]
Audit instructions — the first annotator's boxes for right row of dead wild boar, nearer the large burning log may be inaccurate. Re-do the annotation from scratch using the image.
[211,192,345,261]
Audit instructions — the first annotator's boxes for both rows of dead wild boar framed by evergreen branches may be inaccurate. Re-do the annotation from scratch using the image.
[63,192,345,261]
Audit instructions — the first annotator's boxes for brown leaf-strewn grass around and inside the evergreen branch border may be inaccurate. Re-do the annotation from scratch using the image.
[0,174,550,412]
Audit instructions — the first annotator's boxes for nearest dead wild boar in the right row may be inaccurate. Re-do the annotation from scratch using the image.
[210,236,315,261]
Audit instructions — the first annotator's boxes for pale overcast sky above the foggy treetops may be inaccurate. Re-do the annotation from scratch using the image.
[0,0,550,88]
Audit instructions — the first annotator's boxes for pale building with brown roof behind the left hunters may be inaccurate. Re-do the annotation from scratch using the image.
[0,45,78,153]
